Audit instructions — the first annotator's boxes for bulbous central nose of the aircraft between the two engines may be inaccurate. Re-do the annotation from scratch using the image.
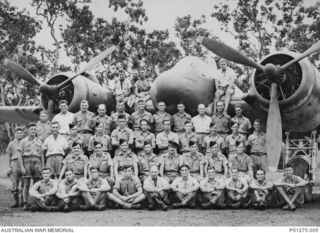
[151,57,217,115]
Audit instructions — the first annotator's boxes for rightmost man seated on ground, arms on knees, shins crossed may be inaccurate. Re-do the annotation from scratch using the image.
[273,164,307,211]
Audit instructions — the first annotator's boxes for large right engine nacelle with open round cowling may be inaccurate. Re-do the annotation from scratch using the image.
[251,52,320,132]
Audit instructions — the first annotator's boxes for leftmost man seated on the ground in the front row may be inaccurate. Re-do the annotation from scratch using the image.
[30,167,59,211]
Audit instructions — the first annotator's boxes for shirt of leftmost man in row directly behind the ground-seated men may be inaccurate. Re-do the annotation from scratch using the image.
[62,154,89,175]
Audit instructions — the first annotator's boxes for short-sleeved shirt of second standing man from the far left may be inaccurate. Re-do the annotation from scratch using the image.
[18,136,42,157]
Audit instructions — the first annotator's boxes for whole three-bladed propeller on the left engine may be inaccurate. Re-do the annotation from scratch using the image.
[4,46,116,116]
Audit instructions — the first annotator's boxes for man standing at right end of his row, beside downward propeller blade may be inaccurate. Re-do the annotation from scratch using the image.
[247,119,268,173]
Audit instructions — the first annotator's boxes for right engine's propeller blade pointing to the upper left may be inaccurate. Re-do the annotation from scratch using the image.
[198,37,263,71]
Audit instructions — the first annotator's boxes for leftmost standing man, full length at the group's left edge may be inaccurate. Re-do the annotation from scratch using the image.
[6,127,24,208]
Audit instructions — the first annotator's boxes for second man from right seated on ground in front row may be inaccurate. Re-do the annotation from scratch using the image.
[250,169,273,209]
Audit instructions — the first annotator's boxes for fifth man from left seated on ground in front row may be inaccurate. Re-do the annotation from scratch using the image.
[143,166,170,211]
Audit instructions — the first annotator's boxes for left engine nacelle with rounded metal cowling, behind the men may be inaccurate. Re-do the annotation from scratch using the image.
[41,73,115,113]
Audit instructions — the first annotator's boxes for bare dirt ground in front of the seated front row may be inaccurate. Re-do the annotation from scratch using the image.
[0,157,320,226]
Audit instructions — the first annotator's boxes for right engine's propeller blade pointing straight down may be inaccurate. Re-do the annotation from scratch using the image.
[267,83,282,172]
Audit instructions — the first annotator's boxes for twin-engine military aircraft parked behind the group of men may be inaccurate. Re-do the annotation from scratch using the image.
[0,38,320,171]
